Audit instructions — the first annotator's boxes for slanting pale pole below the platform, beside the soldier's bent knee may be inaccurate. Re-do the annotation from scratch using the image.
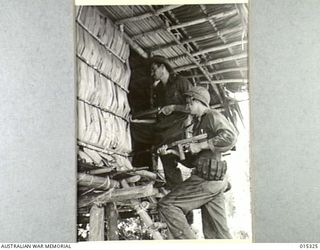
[121,180,163,240]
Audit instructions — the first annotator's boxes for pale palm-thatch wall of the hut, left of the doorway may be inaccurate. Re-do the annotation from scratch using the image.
[76,6,132,168]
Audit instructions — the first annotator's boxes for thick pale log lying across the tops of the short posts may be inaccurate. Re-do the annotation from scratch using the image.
[78,184,158,208]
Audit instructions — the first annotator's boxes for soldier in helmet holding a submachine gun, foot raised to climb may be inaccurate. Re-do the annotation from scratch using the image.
[159,87,237,239]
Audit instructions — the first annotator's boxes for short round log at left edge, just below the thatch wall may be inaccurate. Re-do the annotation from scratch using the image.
[78,173,119,190]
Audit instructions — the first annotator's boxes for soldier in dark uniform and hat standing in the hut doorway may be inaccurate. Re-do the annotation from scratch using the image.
[151,55,193,189]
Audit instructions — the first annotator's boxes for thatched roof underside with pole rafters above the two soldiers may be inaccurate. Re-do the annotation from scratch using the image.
[99,4,248,128]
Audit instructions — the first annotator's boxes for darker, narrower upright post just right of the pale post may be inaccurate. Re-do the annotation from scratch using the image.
[105,202,119,240]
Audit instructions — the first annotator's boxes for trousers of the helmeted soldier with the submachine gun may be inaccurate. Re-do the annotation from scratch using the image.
[159,175,232,239]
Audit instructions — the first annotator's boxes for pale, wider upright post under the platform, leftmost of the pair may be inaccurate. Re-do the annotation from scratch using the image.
[89,204,104,241]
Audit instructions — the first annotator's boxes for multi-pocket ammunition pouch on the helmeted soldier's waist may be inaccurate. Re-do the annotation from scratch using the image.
[195,158,227,181]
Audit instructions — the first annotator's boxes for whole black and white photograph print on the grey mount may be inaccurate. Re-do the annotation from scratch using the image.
[75,3,252,242]
